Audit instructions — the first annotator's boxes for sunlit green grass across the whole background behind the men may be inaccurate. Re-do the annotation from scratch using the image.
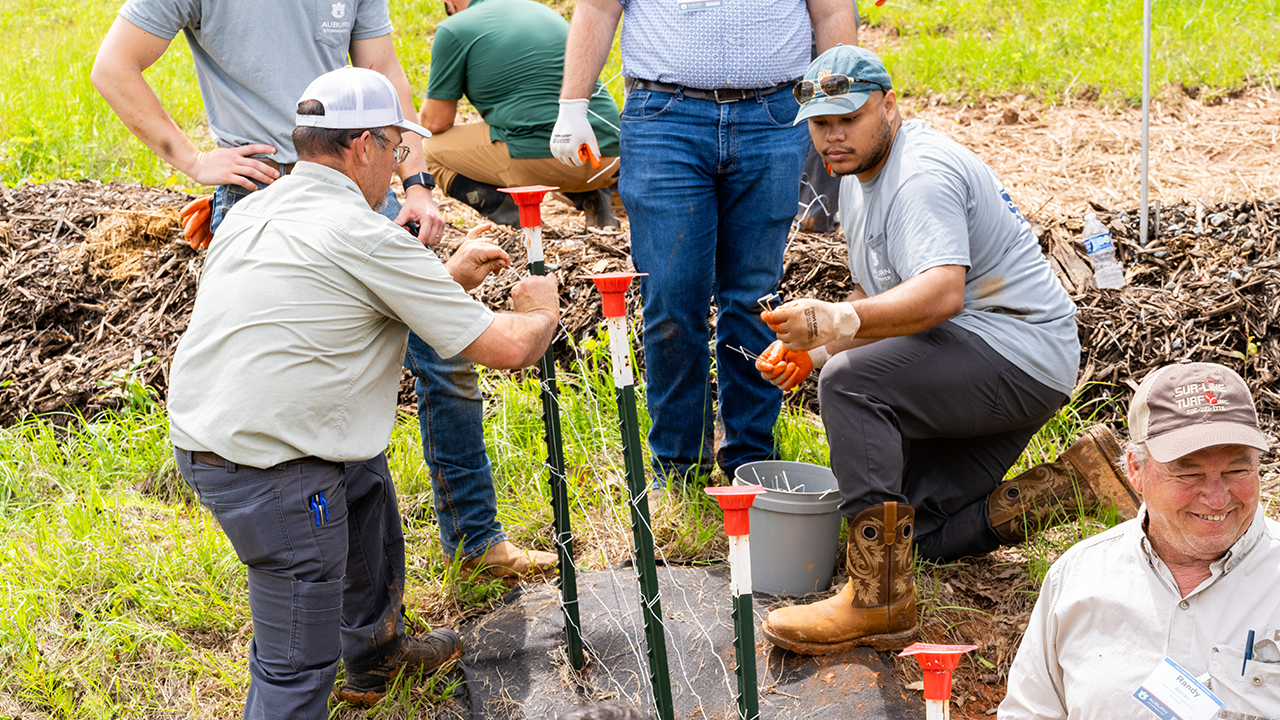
[0,0,1280,184]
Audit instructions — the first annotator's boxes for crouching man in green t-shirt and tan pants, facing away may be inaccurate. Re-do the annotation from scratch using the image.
[419,0,621,227]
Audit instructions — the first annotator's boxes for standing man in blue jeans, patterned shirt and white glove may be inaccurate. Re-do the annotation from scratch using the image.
[552,0,858,483]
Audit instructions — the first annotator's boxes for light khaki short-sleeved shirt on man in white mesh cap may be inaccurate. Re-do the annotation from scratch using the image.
[169,163,493,468]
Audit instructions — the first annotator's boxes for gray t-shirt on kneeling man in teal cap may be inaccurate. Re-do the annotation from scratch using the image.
[840,120,1080,395]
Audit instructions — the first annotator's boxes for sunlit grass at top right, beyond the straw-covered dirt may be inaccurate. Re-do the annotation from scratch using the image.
[859,0,1280,104]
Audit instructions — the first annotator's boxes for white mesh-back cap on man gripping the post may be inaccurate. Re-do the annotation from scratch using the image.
[294,65,431,137]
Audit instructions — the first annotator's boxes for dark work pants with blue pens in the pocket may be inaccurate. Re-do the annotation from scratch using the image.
[174,450,404,720]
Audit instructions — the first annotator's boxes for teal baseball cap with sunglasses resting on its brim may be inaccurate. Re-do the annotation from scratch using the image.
[792,45,893,124]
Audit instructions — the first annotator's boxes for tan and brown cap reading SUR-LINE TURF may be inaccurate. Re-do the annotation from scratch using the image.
[1129,363,1268,462]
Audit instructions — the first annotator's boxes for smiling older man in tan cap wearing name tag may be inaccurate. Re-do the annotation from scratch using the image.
[1000,363,1280,720]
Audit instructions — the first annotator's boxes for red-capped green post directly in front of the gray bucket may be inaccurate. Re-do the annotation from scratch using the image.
[703,486,765,720]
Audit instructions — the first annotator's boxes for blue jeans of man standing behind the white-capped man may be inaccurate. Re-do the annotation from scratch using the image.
[210,186,507,560]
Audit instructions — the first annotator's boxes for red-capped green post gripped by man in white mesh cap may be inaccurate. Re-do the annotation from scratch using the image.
[500,184,585,670]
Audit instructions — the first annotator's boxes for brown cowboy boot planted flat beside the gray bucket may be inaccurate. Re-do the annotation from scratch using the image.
[760,502,919,655]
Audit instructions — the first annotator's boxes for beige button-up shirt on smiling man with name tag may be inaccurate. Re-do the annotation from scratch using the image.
[998,506,1280,720]
